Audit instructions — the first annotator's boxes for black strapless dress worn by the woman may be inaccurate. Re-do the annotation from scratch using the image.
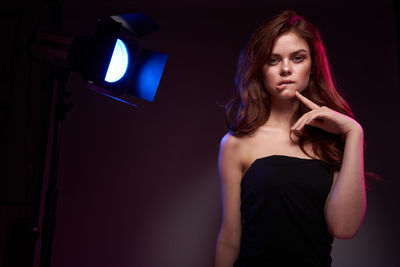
[234,155,333,267]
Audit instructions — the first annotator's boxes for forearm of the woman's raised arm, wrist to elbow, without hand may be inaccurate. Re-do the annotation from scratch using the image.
[325,124,367,239]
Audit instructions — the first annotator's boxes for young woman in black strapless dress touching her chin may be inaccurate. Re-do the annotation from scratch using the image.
[215,11,366,267]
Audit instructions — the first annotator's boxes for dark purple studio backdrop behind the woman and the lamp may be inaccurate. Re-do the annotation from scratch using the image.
[32,0,400,267]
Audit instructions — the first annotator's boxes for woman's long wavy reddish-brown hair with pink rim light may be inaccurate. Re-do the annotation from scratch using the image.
[225,11,355,174]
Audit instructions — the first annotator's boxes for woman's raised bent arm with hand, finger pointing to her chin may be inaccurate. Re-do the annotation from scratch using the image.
[291,92,367,239]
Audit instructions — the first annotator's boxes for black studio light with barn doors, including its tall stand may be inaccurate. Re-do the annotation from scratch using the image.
[29,9,167,267]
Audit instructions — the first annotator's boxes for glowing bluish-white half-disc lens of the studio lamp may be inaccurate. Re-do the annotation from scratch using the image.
[104,39,129,83]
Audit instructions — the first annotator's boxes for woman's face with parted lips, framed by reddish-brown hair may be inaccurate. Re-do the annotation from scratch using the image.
[262,32,311,99]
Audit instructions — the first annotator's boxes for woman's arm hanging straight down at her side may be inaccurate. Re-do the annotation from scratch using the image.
[214,134,242,267]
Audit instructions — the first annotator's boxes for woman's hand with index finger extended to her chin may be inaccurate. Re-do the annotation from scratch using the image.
[290,91,362,135]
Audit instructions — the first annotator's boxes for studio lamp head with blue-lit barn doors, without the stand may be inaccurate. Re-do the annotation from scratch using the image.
[32,13,168,105]
